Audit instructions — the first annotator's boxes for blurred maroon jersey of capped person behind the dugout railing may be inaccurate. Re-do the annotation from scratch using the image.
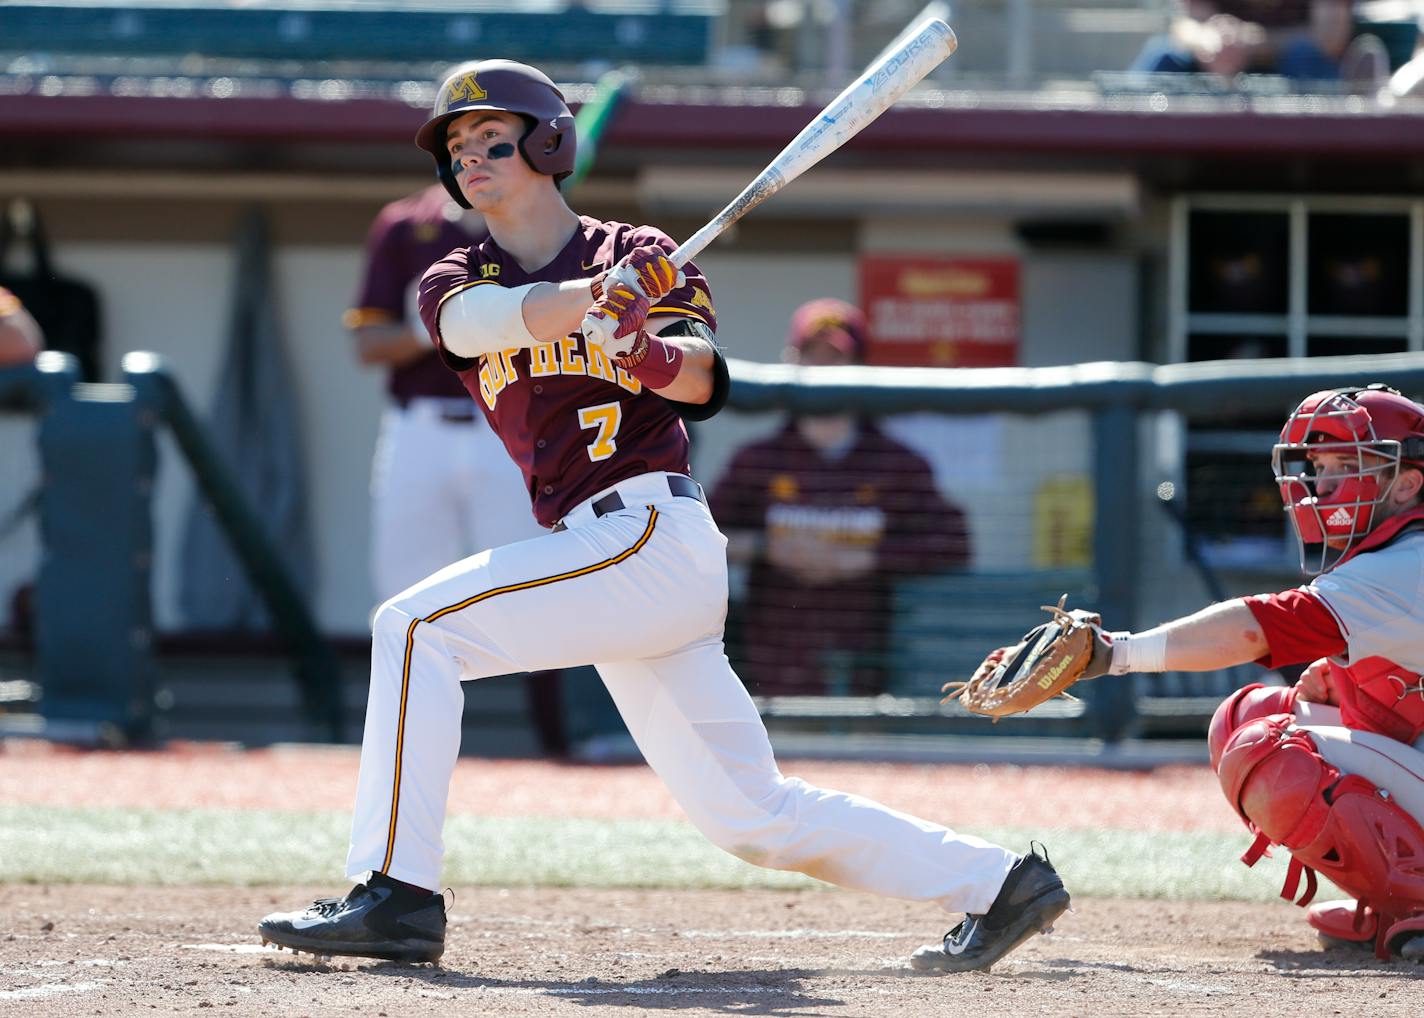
[712,421,968,695]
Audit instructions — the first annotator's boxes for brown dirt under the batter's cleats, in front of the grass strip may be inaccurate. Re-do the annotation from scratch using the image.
[0,886,1424,1018]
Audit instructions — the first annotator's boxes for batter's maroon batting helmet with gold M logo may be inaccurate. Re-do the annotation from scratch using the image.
[416,60,577,208]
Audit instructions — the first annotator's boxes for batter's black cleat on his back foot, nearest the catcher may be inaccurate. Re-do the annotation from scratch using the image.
[910,846,1068,972]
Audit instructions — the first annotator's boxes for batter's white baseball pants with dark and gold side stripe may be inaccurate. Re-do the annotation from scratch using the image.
[346,473,1017,913]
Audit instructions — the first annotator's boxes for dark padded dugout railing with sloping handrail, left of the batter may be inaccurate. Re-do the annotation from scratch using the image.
[0,352,345,743]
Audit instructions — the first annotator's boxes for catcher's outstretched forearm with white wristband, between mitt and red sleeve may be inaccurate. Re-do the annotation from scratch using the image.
[1112,598,1269,673]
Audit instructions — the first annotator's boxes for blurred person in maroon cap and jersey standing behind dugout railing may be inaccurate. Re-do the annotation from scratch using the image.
[712,299,968,696]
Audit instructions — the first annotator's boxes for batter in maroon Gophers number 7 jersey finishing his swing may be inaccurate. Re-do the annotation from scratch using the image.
[259,60,1068,971]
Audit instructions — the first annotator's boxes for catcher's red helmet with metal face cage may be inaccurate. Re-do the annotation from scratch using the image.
[1272,384,1424,572]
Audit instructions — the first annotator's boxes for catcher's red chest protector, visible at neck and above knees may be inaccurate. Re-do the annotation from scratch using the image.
[1330,507,1424,743]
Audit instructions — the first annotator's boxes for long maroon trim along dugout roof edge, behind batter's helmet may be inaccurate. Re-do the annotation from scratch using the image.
[0,95,1424,157]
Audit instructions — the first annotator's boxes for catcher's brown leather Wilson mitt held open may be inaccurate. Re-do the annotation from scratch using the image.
[941,594,1112,722]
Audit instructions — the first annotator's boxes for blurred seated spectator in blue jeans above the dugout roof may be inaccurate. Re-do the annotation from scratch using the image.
[1132,0,1390,90]
